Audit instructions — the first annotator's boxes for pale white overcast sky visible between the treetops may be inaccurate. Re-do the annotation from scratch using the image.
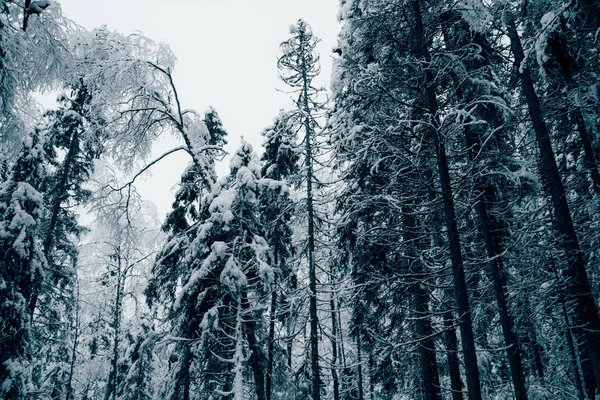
[60,0,339,219]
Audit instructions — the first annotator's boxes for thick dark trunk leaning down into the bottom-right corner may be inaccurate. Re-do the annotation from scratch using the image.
[504,11,600,392]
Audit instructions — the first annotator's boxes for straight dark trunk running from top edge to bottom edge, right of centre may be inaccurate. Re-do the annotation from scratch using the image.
[412,0,482,400]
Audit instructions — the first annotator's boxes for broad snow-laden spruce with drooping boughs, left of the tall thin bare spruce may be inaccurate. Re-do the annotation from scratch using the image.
[148,142,273,399]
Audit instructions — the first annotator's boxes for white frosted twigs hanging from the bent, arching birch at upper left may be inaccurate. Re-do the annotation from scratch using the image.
[67,27,178,168]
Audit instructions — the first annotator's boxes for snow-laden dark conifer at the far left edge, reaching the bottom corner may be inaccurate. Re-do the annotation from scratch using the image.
[0,131,47,399]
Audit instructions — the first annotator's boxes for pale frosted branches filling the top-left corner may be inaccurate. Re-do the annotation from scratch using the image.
[0,0,75,155]
